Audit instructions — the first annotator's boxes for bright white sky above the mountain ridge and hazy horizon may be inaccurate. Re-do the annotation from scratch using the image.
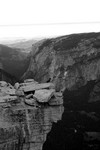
[0,0,100,40]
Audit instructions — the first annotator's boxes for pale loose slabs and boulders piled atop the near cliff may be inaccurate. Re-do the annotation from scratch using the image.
[0,79,63,107]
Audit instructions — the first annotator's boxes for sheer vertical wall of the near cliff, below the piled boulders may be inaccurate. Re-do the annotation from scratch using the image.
[0,105,64,150]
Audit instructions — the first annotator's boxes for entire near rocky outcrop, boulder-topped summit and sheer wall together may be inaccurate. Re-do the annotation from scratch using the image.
[0,79,64,150]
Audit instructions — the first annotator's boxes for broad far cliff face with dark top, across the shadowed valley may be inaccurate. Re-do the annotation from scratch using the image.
[23,33,100,91]
